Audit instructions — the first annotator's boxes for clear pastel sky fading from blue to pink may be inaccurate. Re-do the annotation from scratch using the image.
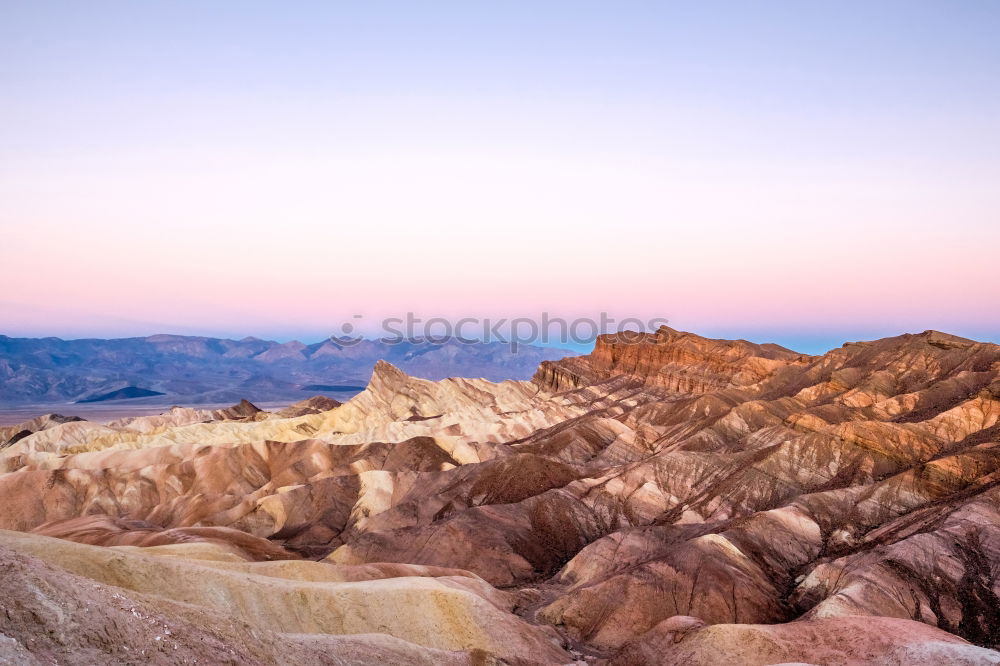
[0,0,1000,352]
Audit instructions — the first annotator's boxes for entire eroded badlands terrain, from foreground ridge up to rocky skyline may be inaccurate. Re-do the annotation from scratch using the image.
[0,327,1000,666]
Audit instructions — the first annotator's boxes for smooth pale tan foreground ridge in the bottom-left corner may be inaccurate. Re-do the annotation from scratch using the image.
[0,533,566,664]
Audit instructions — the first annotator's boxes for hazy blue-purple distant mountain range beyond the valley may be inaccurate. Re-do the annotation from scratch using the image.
[0,335,572,405]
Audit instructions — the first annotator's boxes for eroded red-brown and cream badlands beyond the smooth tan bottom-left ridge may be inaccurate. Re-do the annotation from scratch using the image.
[0,328,1000,664]
